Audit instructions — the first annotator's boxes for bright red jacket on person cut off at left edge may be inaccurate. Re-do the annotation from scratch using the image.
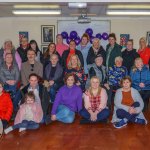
[0,92,13,121]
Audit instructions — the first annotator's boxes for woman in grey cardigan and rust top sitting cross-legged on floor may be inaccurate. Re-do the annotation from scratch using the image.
[112,76,147,128]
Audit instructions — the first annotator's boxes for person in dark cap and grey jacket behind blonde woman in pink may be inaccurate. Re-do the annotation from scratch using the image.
[86,54,108,88]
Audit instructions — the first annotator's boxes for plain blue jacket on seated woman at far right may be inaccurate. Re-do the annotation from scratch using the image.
[130,66,150,91]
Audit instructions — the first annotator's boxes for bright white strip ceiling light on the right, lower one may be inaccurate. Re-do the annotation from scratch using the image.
[107,10,150,16]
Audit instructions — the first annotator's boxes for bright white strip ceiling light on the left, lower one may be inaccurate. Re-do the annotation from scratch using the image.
[12,10,61,15]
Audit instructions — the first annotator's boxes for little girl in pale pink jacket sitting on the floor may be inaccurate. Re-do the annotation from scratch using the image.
[4,91,43,134]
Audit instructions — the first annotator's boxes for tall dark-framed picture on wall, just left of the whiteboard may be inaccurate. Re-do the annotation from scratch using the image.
[41,25,55,44]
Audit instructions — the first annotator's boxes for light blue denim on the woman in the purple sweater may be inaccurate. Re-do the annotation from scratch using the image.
[56,105,75,123]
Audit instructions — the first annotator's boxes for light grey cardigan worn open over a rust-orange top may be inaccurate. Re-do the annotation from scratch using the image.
[111,88,147,123]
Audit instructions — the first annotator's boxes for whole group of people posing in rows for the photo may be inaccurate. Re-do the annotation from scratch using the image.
[0,33,150,134]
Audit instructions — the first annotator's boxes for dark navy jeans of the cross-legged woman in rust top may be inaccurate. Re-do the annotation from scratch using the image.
[116,102,140,123]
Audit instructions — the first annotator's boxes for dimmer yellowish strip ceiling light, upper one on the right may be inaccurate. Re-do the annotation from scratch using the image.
[108,5,150,9]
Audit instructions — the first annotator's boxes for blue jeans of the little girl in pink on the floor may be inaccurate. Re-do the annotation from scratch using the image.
[12,120,39,130]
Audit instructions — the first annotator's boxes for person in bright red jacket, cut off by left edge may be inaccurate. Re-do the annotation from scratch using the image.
[0,82,13,135]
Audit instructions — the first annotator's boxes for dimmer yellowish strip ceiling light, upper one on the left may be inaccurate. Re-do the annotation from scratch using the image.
[13,5,60,9]
